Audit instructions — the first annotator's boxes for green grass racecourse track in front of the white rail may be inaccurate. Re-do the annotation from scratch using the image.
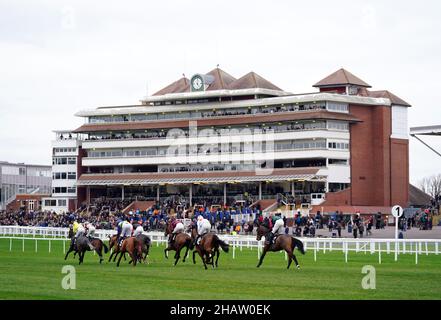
[0,239,441,300]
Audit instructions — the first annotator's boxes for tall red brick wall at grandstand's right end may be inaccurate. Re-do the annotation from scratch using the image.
[350,105,409,207]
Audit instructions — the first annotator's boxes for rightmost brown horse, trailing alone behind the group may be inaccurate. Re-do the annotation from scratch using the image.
[256,225,305,269]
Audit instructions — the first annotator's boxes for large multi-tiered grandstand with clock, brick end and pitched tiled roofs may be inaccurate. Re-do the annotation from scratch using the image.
[72,68,410,213]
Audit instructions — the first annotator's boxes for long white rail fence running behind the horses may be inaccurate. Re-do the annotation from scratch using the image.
[0,226,441,264]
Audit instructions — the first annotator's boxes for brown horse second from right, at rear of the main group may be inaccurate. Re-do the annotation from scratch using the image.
[190,223,230,269]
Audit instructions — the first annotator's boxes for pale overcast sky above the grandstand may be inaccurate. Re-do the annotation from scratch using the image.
[0,0,441,183]
